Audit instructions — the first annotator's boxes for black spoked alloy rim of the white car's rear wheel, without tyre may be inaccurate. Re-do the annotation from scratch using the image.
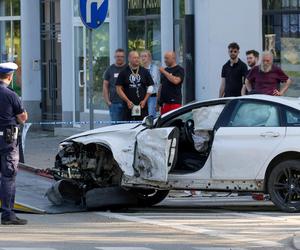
[273,167,300,207]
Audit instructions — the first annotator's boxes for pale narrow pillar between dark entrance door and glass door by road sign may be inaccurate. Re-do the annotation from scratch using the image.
[60,0,75,121]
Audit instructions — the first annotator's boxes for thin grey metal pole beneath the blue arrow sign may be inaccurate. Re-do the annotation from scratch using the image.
[88,29,94,129]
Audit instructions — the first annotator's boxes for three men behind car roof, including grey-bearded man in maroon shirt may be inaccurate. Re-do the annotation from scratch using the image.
[219,43,292,97]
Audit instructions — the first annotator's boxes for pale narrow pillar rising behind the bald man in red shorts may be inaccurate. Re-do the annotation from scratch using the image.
[160,0,174,62]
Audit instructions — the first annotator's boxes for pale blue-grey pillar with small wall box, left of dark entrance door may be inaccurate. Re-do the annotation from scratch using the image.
[21,0,41,121]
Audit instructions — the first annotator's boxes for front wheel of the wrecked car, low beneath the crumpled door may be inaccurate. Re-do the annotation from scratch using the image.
[133,189,169,207]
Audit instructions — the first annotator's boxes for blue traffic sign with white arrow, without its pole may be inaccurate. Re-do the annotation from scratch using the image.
[80,0,108,29]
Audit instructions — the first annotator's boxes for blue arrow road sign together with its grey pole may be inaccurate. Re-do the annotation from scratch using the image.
[79,0,108,129]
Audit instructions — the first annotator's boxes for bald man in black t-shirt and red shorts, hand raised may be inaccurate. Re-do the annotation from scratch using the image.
[157,51,184,114]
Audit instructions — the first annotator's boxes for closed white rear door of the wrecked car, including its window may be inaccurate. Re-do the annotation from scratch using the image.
[211,99,286,180]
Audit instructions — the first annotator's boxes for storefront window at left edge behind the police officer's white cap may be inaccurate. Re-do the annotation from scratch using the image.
[0,0,21,95]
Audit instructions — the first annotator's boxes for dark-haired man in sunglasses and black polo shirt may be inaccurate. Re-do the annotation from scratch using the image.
[219,43,248,97]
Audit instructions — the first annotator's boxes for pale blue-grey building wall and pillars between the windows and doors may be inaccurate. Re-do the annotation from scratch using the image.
[21,0,262,121]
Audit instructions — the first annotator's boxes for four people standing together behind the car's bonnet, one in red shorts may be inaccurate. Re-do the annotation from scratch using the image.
[103,49,184,121]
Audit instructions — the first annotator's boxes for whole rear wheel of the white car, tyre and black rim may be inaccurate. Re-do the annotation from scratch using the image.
[268,160,300,212]
